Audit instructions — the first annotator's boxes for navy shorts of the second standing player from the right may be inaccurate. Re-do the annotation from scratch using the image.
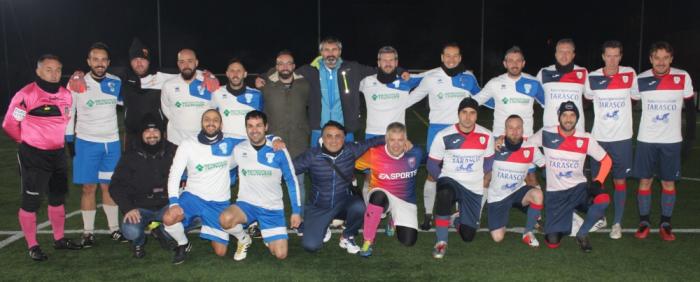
[591,139,634,179]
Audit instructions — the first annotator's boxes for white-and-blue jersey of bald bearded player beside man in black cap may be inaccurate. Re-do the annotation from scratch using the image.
[160,71,212,145]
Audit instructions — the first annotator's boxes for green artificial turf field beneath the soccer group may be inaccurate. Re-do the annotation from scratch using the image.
[0,103,700,281]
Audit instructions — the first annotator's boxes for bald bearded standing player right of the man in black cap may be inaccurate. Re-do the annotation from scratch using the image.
[160,49,212,146]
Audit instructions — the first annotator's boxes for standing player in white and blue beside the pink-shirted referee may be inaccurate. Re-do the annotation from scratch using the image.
[66,42,126,247]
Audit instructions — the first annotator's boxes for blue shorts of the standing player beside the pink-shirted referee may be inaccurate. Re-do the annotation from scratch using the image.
[73,138,122,184]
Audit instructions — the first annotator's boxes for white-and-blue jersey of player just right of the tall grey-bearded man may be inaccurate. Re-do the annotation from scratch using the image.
[360,74,421,135]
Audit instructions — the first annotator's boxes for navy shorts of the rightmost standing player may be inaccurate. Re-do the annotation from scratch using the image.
[634,141,682,181]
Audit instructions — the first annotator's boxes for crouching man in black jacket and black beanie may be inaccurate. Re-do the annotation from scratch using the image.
[109,114,176,258]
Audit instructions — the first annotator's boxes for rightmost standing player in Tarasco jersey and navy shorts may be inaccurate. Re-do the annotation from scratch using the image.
[633,42,695,241]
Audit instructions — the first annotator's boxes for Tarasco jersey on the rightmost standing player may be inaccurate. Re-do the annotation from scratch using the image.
[632,68,695,144]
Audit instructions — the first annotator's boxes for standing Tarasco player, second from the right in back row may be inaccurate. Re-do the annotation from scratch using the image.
[584,40,637,239]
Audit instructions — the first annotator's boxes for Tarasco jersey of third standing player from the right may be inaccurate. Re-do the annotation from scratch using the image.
[537,65,588,132]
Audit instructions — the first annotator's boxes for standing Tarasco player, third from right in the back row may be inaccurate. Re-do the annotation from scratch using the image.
[537,38,588,132]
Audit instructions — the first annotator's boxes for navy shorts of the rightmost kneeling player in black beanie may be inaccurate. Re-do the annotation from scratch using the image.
[544,183,593,235]
